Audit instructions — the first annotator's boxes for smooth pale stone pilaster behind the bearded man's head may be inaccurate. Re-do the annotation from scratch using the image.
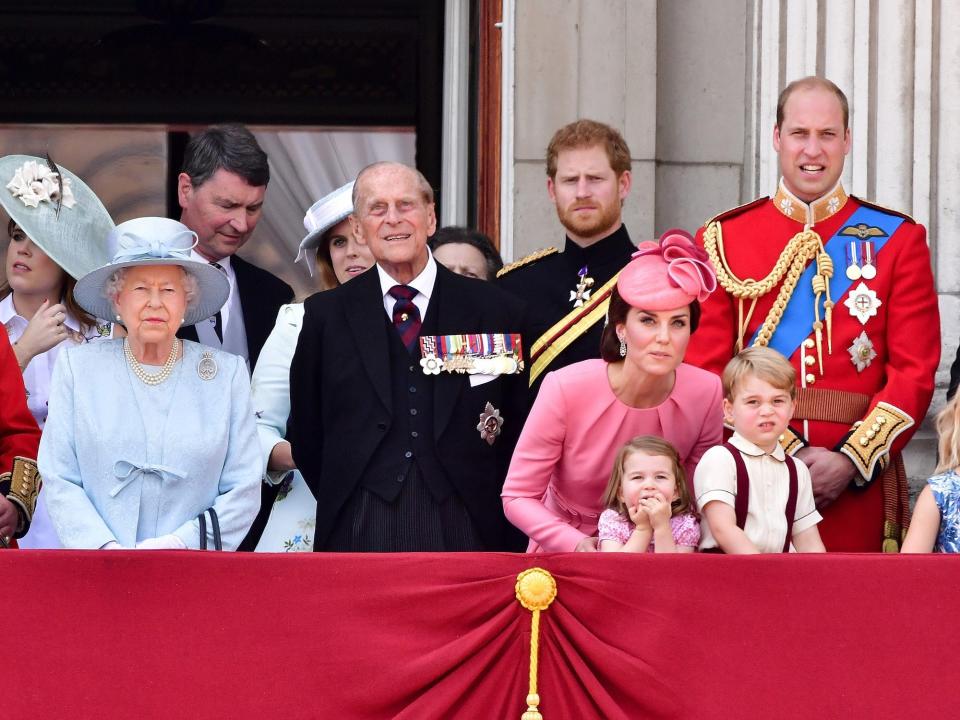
[504,0,657,261]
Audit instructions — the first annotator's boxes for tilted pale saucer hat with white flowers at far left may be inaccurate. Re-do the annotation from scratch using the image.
[0,155,114,280]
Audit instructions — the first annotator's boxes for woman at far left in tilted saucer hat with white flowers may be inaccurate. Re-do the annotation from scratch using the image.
[0,155,113,548]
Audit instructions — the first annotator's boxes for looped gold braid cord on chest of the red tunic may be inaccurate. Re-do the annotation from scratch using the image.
[703,221,833,358]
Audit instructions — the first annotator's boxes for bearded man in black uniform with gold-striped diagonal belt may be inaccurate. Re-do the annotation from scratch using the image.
[497,120,636,397]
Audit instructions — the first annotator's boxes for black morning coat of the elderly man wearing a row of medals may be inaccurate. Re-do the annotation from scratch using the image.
[287,264,528,551]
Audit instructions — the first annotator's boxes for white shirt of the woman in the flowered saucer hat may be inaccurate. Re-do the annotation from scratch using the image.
[0,293,113,549]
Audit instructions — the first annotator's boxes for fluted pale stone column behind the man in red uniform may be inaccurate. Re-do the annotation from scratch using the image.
[744,0,960,486]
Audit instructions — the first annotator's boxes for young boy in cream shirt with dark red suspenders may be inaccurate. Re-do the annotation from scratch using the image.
[693,347,825,554]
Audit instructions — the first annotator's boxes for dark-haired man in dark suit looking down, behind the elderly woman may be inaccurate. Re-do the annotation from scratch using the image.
[177,125,293,551]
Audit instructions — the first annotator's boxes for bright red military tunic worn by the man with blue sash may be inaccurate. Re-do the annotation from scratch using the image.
[685,186,940,551]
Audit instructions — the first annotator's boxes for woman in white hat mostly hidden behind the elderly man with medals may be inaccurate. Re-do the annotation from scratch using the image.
[251,182,374,552]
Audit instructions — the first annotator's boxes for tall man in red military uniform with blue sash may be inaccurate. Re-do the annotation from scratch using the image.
[686,77,940,552]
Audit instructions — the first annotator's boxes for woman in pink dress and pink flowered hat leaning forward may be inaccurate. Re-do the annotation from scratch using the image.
[502,230,723,552]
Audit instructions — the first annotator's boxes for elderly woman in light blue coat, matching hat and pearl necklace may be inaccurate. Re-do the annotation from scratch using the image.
[38,218,260,549]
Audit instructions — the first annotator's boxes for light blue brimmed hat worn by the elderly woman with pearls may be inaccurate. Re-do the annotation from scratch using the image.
[73,217,230,325]
